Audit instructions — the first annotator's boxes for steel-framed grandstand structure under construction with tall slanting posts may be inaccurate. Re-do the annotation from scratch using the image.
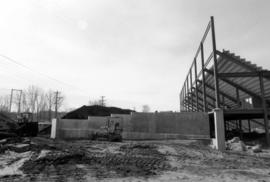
[180,17,270,145]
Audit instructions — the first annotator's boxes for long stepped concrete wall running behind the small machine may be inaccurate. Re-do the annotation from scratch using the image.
[57,112,209,140]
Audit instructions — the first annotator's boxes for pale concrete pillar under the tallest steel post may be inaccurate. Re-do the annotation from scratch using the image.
[213,108,226,151]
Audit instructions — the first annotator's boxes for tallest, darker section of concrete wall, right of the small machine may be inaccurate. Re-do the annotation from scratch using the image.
[123,112,210,139]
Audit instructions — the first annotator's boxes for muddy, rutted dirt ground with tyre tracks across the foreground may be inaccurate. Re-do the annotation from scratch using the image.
[0,137,270,182]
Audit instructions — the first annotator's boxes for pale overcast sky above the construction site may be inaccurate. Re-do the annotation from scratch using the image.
[0,0,270,111]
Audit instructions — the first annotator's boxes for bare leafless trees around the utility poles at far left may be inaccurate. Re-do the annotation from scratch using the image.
[0,85,65,121]
